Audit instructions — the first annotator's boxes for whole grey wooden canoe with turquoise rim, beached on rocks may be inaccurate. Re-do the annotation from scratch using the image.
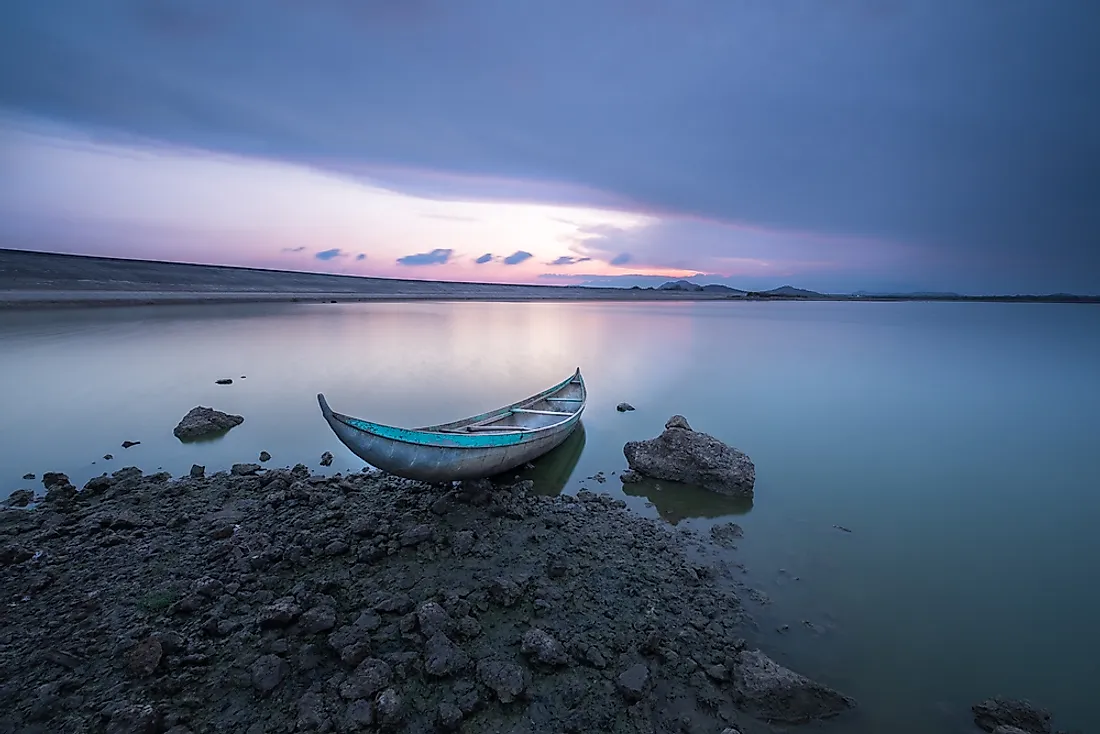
[317,369,587,482]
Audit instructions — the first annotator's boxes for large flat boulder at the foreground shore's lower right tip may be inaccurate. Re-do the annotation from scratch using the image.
[733,650,856,724]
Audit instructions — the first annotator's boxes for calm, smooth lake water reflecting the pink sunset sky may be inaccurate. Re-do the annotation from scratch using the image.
[0,303,1100,733]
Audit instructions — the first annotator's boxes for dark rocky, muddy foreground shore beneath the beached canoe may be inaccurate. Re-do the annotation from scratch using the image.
[0,464,855,734]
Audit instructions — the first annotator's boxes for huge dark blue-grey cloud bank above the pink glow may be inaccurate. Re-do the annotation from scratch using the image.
[0,0,1100,291]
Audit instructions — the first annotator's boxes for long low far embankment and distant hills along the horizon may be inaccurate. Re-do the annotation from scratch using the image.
[0,249,1100,310]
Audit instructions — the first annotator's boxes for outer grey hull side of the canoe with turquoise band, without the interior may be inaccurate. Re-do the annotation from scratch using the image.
[317,371,584,482]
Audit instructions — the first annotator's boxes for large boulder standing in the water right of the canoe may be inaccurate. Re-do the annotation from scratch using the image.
[623,415,756,497]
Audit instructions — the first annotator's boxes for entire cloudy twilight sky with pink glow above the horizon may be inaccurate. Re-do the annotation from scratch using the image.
[0,0,1100,294]
